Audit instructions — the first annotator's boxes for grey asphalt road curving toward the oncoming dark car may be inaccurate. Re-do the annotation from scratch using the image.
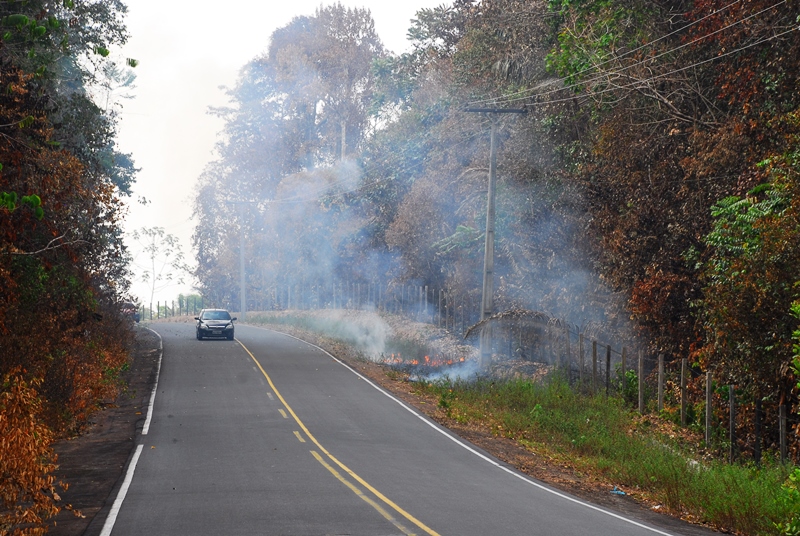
[106,324,692,536]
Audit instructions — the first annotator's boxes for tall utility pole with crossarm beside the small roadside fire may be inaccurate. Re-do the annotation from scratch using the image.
[464,108,528,369]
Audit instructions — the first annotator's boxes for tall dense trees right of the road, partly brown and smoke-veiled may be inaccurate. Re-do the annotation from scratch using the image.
[195,0,800,460]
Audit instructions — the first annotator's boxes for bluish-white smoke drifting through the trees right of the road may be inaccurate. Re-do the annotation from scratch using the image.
[191,6,635,377]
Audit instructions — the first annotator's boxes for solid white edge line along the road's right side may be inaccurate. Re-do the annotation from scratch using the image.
[244,325,673,536]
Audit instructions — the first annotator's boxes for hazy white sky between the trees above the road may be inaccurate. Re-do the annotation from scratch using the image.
[118,0,446,301]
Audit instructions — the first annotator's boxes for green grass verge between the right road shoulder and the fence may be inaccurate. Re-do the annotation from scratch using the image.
[420,374,791,534]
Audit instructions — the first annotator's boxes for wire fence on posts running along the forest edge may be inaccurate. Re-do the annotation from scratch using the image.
[139,282,800,462]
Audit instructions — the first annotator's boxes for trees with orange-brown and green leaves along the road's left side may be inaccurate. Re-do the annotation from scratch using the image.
[0,0,135,534]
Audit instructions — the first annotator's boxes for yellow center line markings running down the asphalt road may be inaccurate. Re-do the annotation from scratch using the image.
[237,339,439,536]
